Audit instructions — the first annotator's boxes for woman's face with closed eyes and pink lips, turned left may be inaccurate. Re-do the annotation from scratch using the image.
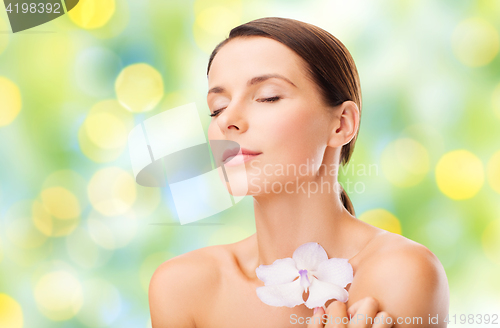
[207,37,334,195]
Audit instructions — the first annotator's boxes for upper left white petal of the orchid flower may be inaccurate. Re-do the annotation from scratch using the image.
[255,257,299,286]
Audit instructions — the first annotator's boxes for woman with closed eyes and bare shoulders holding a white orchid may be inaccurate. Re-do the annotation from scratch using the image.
[149,17,449,328]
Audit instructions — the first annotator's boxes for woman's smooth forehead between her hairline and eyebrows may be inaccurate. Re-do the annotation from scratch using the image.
[208,36,306,85]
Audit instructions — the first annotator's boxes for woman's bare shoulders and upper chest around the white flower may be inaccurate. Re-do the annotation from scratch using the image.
[150,215,448,328]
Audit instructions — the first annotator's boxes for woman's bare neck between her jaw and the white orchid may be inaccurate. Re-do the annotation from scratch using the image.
[254,177,355,267]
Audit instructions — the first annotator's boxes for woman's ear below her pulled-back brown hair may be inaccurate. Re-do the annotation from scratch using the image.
[328,100,360,147]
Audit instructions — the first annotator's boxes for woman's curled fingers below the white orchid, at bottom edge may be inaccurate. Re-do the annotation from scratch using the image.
[307,297,394,328]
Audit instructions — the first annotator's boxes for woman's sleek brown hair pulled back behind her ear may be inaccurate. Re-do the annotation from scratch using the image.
[207,17,361,215]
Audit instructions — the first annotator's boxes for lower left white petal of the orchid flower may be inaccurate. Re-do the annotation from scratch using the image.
[257,279,304,308]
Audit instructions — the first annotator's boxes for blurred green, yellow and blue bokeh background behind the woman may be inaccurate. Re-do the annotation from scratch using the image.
[0,0,500,328]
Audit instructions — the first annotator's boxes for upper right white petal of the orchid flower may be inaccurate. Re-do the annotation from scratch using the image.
[312,258,353,287]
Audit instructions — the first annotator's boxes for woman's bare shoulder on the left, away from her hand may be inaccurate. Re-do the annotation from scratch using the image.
[149,246,227,328]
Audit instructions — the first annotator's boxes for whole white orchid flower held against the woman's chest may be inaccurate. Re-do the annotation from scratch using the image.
[255,242,353,309]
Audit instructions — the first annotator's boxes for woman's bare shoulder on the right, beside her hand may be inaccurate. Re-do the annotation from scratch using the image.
[358,233,449,327]
